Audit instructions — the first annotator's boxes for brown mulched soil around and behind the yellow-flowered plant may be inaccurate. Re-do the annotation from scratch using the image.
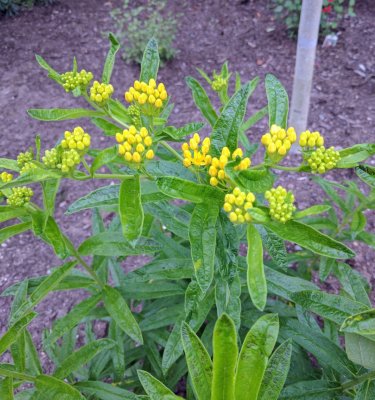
[0,0,375,356]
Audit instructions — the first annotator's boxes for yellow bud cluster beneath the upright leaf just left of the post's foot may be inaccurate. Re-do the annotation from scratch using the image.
[261,124,297,157]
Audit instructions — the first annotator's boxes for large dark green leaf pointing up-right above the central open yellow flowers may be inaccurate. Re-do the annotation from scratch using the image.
[210,81,255,157]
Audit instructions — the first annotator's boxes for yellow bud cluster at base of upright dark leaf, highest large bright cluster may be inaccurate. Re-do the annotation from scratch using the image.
[125,79,168,114]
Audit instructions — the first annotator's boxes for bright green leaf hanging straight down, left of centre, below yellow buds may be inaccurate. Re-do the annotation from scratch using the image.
[119,175,144,241]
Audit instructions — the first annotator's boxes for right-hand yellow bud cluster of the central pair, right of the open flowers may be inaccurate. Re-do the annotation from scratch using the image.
[208,147,251,186]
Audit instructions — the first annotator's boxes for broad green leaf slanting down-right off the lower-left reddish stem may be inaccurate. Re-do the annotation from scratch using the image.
[103,286,143,343]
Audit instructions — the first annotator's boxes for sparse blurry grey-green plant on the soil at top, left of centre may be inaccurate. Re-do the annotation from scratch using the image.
[111,0,178,65]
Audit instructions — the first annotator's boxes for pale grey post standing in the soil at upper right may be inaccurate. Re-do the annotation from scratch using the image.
[289,0,323,134]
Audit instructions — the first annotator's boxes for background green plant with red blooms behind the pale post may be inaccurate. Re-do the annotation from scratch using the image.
[271,0,356,37]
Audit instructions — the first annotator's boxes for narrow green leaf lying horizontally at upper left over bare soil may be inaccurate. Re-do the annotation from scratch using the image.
[27,108,105,121]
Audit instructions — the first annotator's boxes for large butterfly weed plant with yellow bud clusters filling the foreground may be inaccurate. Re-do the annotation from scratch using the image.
[0,35,375,400]
